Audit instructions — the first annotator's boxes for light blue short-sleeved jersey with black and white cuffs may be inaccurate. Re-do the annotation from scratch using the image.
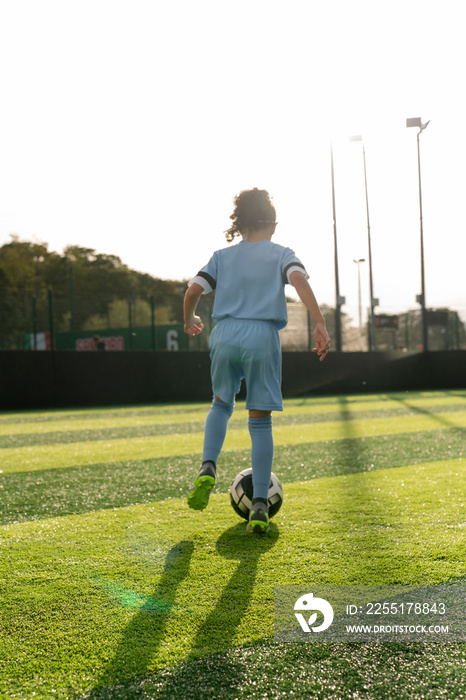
[189,241,309,330]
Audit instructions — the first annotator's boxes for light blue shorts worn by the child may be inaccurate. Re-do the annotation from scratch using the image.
[209,318,283,411]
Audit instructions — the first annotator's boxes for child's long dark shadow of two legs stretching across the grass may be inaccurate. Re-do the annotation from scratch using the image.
[84,522,279,700]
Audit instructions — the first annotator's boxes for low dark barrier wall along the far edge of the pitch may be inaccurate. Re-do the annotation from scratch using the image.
[0,350,466,410]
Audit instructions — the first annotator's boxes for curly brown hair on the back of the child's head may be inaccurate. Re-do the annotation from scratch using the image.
[225,187,276,243]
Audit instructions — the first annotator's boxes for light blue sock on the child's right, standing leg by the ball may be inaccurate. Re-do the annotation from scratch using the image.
[248,416,273,500]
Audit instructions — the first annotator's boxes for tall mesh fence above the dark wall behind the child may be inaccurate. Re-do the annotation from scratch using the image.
[0,290,466,352]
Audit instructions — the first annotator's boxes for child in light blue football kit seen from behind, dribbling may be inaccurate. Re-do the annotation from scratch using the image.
[184,188,330,532]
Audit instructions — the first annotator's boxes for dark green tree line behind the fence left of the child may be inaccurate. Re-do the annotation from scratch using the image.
[0,235,186,349]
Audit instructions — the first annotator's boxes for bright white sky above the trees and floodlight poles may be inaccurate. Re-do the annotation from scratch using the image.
[0,0,466,318]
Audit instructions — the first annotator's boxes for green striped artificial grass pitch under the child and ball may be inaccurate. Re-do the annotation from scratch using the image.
[0,390,466,700]
